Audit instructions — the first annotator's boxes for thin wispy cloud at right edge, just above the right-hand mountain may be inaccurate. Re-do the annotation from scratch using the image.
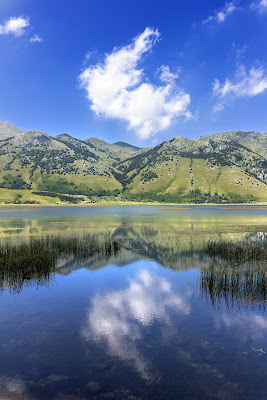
[213,65,267,112]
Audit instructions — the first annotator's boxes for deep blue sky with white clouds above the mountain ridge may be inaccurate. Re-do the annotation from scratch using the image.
[0,0,267,146]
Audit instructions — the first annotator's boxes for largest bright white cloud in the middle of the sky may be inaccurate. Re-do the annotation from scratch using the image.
[79,28,192,139]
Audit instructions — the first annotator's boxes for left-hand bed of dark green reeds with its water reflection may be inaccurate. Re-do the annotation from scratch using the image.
[0,234,120,293]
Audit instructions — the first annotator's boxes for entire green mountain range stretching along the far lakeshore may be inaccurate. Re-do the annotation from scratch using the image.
[0,123,267,203]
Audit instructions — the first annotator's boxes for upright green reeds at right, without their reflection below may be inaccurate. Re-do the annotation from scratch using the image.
[205,240,267,262]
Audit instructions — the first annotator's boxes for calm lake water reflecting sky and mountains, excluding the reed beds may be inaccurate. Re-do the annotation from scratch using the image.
[0,207,267,400]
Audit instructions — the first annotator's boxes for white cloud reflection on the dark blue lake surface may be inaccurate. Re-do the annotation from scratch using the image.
[82,268,190,381]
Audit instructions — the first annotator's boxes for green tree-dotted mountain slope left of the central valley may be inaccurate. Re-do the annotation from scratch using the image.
[0,131,121,194]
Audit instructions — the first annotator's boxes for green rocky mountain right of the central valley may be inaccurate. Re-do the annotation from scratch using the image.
[117,137,267,202]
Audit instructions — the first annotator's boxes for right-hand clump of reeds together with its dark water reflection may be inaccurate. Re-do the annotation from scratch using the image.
[200,238,267,310]
